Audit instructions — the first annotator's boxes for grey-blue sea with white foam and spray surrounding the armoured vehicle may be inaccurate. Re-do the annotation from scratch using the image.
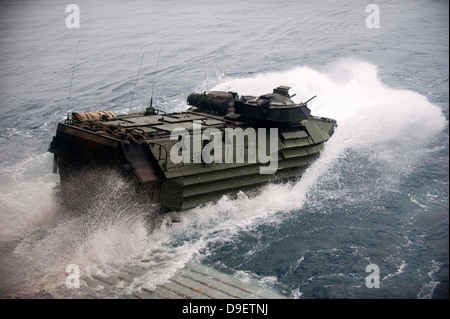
[0,0,449,299]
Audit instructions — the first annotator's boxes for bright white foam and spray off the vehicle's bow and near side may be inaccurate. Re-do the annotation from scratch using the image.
[86,60,446,296]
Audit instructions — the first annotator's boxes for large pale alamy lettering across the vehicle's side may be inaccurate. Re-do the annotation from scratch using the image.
[170,121,278,174]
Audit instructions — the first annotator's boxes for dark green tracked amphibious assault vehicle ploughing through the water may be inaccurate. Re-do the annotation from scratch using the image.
[49,86,337,211]
